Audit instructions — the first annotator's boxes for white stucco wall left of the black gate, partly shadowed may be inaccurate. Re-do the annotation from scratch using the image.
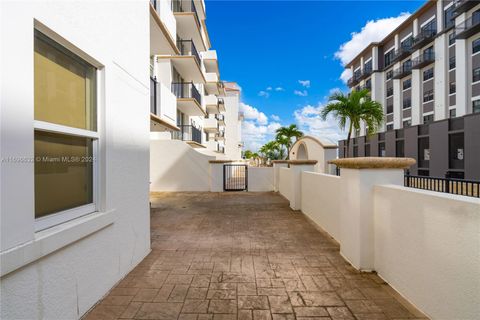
[150,140,215,192]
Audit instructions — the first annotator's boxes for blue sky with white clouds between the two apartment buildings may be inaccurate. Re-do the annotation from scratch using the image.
[206,0,423,149]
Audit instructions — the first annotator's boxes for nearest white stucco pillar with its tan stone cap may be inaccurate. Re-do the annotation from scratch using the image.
[330,158,415,271]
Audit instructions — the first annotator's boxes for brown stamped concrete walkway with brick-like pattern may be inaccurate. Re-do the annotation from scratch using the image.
[86,193,424,320]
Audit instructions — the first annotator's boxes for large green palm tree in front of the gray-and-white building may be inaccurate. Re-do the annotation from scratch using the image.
[320,89,384,157]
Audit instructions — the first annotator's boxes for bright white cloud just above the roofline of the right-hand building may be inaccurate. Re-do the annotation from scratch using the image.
[335,12,410,83]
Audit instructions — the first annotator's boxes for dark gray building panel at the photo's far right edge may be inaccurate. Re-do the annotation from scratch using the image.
[464,114,480,180]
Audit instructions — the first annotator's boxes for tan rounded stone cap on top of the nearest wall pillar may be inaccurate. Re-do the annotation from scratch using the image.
[328,157,416,169]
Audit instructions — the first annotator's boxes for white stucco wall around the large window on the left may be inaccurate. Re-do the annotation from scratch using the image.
[0,1,150,319]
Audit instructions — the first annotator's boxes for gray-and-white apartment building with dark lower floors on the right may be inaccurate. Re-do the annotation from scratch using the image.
[339,0,480,180]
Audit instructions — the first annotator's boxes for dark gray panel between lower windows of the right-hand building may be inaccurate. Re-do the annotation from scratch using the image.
[428,120,448,177]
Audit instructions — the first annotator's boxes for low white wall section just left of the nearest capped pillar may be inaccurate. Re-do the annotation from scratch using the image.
[301,172,341,241]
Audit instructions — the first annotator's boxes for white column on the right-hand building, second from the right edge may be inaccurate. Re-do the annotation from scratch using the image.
[433,34,449,121]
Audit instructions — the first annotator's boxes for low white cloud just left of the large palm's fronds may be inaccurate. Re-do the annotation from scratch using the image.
[293,103,345,143]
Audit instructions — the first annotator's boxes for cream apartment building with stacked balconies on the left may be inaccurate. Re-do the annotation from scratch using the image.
[150,0,240,158]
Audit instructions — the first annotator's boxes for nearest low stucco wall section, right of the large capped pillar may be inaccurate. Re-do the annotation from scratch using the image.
[375,186,480,319]
